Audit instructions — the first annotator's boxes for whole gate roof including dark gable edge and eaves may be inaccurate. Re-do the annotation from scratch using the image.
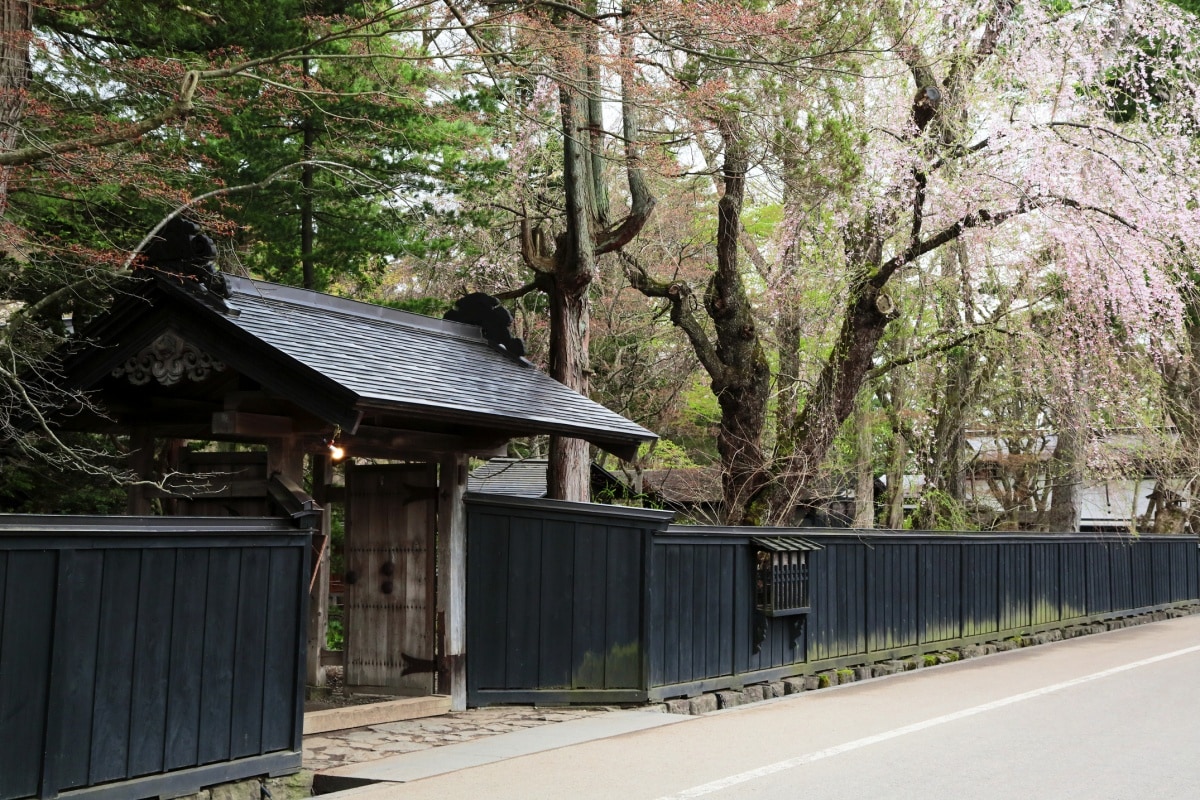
[63,276,655,457]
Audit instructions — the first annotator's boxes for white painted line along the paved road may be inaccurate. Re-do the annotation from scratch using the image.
[658,645,1200,800]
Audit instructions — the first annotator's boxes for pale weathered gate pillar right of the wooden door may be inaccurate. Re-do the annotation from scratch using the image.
[438,453,467,711]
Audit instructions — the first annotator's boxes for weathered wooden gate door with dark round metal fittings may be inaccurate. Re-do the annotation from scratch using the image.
[343,464,437,694]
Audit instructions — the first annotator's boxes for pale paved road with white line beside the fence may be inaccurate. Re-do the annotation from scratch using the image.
[336,616,1200,800]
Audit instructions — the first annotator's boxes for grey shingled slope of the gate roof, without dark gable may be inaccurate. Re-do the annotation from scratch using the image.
[219,277,655,443]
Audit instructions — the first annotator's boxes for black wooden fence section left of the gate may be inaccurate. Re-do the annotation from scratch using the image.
[0,515,310,800]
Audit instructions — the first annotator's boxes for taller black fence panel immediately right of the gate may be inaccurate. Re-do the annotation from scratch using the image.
[467,495,673,705]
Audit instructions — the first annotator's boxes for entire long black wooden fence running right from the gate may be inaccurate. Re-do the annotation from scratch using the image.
[467,497,1200,705]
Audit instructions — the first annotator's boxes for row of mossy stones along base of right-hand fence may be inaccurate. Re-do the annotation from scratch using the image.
[658,604,1200,715]
